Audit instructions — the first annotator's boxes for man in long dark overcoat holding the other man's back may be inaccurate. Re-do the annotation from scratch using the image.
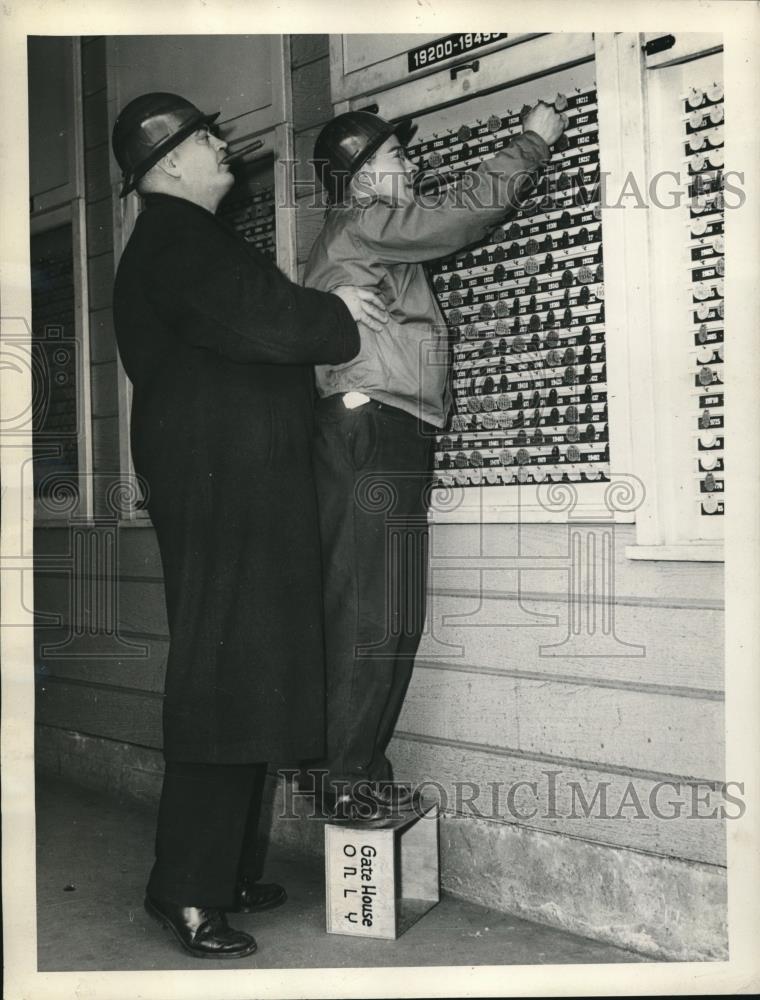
[113,94,385,958]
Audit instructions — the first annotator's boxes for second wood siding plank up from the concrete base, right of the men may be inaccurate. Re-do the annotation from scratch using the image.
[398,668,724,780]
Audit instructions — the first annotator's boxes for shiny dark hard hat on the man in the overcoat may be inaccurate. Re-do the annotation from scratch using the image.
[111,93,220,198]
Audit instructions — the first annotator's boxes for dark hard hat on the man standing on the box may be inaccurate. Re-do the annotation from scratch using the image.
[312,111,417,202]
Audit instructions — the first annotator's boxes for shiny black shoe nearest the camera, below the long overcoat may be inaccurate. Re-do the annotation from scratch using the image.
[145,896,256,958]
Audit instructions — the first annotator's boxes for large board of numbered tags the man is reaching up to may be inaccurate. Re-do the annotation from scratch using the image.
[409,87,610,486]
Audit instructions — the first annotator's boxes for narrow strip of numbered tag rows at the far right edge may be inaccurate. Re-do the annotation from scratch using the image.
[682,83,725,516]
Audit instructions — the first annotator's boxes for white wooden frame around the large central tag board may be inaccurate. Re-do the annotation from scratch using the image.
[335,32,640,524]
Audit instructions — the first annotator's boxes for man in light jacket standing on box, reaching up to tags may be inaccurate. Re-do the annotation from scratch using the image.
[304,103,565,818]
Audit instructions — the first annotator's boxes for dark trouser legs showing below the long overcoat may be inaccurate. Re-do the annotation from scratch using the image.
[148,760,267,909]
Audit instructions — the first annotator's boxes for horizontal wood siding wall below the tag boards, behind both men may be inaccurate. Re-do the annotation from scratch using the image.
[35,525,725,865]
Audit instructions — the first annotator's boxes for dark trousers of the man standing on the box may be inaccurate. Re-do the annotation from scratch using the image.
[308,394,436,784]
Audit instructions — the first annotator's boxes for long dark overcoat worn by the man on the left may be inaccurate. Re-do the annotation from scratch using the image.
[114,195,359,764]
